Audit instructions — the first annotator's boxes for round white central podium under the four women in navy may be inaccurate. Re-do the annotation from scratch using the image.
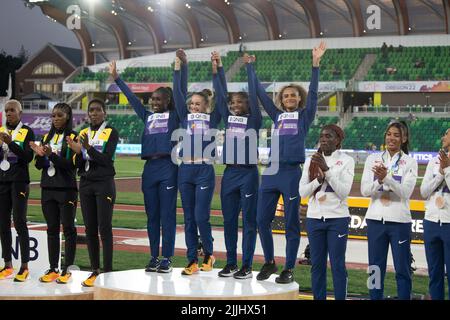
[94,268,299,300]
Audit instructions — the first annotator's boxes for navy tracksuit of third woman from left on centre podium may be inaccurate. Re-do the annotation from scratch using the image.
[213,65,262,267]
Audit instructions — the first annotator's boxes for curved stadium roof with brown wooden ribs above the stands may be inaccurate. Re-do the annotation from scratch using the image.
[22,0,450,65]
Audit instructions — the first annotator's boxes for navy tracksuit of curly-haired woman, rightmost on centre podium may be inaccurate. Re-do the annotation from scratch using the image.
[248,66,319,269]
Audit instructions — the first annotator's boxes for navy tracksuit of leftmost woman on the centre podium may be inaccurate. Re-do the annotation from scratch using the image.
[116,78,179,258]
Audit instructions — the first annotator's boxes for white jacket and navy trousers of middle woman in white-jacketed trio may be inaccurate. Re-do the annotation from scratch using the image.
[361,151,417,300]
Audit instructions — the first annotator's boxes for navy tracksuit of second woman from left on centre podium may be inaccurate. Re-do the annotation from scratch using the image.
[173,64,220,262]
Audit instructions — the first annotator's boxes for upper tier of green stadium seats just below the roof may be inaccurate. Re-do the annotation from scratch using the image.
[73,46,450,83]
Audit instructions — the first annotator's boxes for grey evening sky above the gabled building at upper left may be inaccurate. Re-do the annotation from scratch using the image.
[0,0,80,55]
